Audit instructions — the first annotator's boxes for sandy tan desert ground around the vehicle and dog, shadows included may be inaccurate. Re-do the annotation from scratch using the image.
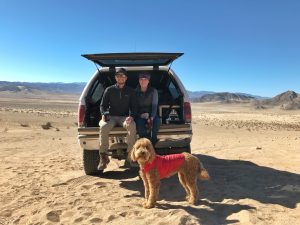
[0,99,300,225]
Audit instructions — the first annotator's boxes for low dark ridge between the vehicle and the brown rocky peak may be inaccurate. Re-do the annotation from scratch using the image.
[193,92,255,103]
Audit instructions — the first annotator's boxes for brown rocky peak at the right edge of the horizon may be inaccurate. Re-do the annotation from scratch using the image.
[255,91,300,110]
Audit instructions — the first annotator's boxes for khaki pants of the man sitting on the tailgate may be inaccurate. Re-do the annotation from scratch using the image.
[99,116,136,153]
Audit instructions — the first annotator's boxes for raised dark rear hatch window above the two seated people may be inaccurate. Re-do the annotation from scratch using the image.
[82,52,183,67]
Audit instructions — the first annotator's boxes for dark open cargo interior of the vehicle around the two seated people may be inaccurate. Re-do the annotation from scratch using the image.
[85,70,185,127]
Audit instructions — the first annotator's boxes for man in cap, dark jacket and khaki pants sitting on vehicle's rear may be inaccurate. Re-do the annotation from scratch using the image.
[98,68,136,170]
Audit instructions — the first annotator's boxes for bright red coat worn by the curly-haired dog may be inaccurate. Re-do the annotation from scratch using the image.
[143,154,185,179]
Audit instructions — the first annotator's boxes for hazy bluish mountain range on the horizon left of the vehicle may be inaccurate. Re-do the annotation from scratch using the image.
[0,81,86,95]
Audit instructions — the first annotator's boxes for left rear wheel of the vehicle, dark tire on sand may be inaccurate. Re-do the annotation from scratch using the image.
[83,149,103,175]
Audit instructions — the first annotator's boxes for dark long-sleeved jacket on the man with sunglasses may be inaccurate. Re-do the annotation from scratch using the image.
[100,84,136,117]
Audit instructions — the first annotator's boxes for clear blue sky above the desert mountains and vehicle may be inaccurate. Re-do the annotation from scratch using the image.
[0,0,300,97]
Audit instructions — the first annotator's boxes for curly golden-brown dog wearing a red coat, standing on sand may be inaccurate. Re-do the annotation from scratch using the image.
[129,138,209,209]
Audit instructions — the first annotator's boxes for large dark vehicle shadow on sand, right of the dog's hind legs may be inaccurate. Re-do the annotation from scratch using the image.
[198,155,300,208]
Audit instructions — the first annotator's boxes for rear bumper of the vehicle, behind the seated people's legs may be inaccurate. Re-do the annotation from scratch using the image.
[78,124,193,150]
